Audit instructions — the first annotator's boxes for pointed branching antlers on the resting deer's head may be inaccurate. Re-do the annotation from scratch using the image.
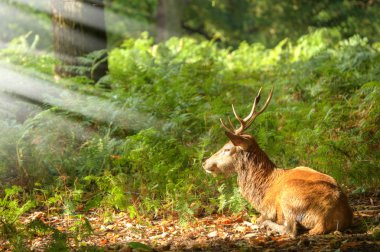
[220,88,273,135]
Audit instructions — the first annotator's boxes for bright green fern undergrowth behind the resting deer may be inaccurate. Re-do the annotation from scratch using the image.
[0,29,380,249]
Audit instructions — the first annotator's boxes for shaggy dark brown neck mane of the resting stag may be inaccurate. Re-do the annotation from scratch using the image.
[235,142,276,209]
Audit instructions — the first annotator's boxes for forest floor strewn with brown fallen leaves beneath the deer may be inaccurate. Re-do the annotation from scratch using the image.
[0,192,380,252]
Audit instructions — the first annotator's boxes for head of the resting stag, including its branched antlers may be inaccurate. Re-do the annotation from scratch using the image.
[203,88,273,175]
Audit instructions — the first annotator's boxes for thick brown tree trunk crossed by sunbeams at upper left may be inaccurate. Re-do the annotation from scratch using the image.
[51,0,108,81]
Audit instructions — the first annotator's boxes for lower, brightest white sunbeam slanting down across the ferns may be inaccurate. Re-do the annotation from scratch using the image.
[0,63,158,130]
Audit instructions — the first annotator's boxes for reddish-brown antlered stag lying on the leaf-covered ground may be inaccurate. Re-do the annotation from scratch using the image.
[203,89,353,236]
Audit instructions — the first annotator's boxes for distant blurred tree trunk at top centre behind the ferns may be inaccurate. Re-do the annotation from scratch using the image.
[156,0,184,42]
